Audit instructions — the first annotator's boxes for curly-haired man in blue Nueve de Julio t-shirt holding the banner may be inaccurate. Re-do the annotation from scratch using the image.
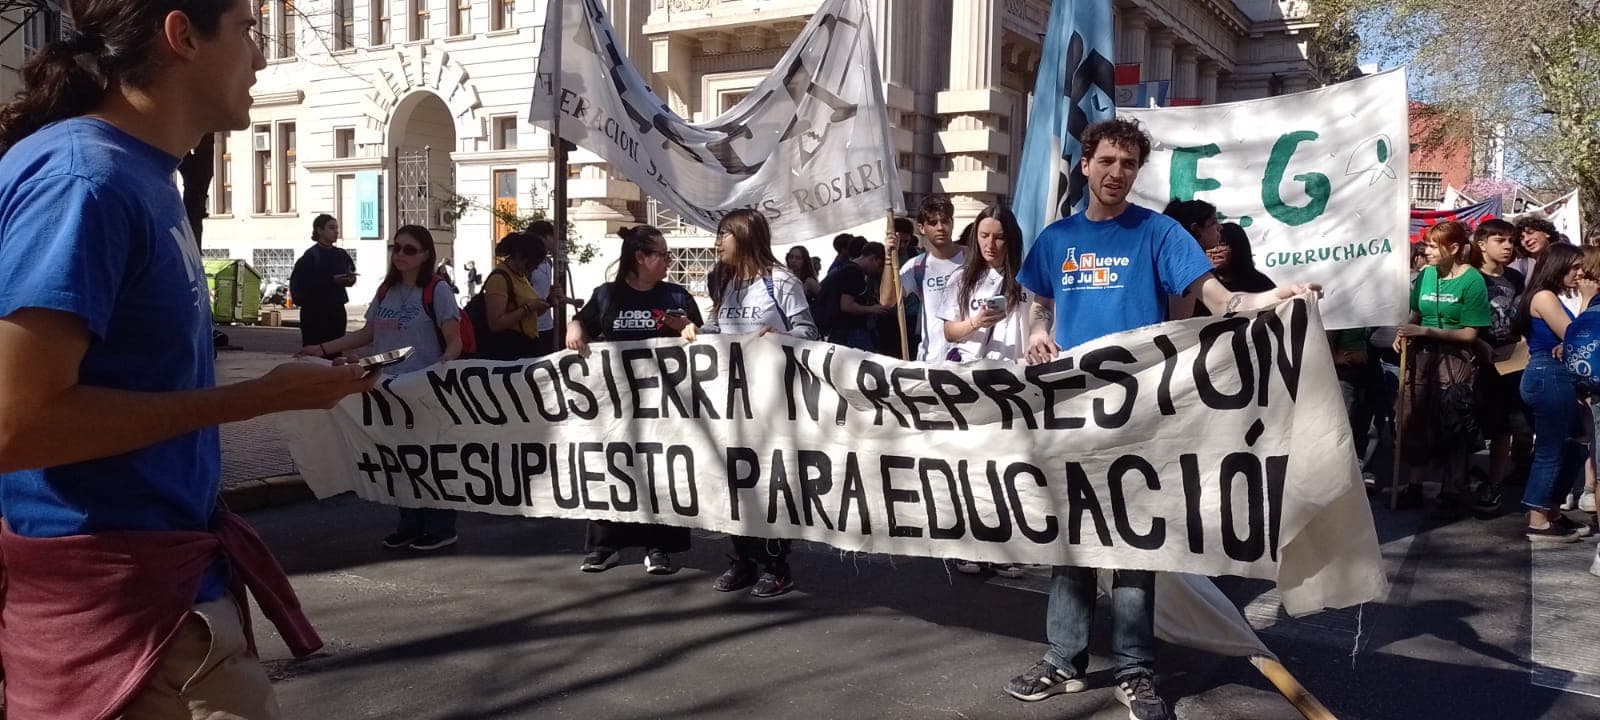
[1006,120,1315,720]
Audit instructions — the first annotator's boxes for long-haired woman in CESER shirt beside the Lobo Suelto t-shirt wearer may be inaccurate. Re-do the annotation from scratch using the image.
[701,210,816,597]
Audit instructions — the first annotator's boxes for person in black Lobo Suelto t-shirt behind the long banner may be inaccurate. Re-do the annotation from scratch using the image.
[566,226,702,574]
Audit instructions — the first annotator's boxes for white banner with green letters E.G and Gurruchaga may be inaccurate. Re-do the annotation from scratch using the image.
[1117,70,1411,330]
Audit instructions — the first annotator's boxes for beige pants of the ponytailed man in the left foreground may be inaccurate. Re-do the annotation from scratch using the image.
[122,595,278,720]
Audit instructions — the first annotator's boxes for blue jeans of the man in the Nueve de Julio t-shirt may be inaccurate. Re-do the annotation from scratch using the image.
[1045,566,1155,682]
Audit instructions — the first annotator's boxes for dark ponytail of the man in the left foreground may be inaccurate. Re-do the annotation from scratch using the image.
[0,35,107,155]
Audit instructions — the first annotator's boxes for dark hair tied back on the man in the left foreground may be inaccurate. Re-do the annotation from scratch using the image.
[0,0,237,154]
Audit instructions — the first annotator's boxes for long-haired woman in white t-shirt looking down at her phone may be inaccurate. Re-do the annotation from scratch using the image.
[934,205,1034,578]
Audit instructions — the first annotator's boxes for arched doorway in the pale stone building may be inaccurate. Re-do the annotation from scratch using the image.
[389,90,456,259]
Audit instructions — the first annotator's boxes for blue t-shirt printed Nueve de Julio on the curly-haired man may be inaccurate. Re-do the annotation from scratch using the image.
[1018,203,1211,350]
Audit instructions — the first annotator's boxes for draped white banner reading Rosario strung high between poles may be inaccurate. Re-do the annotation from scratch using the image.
[528,0,904,243]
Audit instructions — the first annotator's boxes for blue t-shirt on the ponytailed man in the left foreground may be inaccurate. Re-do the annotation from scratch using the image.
[0,118,227,602]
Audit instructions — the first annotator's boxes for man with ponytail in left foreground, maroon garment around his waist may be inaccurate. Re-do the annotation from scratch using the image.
[0,0,376,720]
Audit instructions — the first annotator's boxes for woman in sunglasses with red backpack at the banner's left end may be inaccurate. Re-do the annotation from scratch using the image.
[299,226,461,550]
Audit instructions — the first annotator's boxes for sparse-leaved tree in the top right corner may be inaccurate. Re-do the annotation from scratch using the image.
[1314,0,1600,227]
